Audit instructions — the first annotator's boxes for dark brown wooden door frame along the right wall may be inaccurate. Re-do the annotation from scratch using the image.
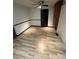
[53,0,63,30]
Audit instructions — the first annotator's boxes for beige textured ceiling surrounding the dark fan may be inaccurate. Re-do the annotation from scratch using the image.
[13,0,58,8]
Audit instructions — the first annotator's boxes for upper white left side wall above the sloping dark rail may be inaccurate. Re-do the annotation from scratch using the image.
[13,3,29,24]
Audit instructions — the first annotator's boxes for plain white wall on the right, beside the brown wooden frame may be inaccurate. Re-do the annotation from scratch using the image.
[57,5,66,43]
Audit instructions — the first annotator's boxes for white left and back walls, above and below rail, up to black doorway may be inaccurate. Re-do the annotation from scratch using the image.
[13,3,41,35]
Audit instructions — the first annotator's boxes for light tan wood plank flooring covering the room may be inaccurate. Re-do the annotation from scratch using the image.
[13,27,66,59]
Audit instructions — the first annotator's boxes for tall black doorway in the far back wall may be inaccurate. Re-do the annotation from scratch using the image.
[41,9,49,27]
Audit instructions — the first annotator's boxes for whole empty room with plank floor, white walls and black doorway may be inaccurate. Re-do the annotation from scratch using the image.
[13,0,66,59]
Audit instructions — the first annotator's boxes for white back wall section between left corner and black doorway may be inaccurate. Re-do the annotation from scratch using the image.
[30,8,41,26]
